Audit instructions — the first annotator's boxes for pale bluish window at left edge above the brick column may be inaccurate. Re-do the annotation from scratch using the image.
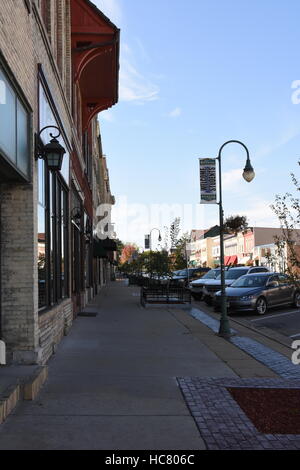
[0,64,30,180]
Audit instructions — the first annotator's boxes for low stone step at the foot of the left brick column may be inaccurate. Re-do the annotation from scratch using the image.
[0,366,48,424]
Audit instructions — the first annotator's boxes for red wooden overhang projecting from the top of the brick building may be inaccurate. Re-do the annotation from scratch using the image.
[71,0,120,130]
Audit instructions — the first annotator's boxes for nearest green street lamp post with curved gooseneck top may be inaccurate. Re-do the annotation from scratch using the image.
[217,140,255,338]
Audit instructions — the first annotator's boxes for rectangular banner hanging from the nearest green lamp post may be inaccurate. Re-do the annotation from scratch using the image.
[199,158,217,204]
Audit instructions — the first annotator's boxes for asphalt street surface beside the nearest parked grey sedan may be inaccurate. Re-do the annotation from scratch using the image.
[194,301,300,340]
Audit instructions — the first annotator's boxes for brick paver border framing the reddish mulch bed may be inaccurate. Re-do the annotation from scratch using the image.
[177,377,300,450]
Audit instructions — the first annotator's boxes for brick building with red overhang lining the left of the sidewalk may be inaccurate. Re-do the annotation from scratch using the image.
[0,0,119,364]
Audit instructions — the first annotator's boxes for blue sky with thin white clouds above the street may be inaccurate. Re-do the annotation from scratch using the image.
[90,0,300,247]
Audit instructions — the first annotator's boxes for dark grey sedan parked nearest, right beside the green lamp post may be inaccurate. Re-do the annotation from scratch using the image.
[214,272,300,315]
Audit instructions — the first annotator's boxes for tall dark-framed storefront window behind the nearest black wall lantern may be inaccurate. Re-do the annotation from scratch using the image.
[38,76,69,309]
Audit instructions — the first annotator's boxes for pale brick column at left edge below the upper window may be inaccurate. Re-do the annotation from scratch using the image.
[0,184,41,364]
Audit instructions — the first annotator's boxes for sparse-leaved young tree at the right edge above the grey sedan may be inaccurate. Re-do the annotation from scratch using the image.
[270,162,300,281]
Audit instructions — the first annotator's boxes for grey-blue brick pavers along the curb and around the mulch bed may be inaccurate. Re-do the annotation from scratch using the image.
[177,308,300,450]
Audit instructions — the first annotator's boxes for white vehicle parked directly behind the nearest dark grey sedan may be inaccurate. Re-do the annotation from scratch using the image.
[203,266,269,305]
